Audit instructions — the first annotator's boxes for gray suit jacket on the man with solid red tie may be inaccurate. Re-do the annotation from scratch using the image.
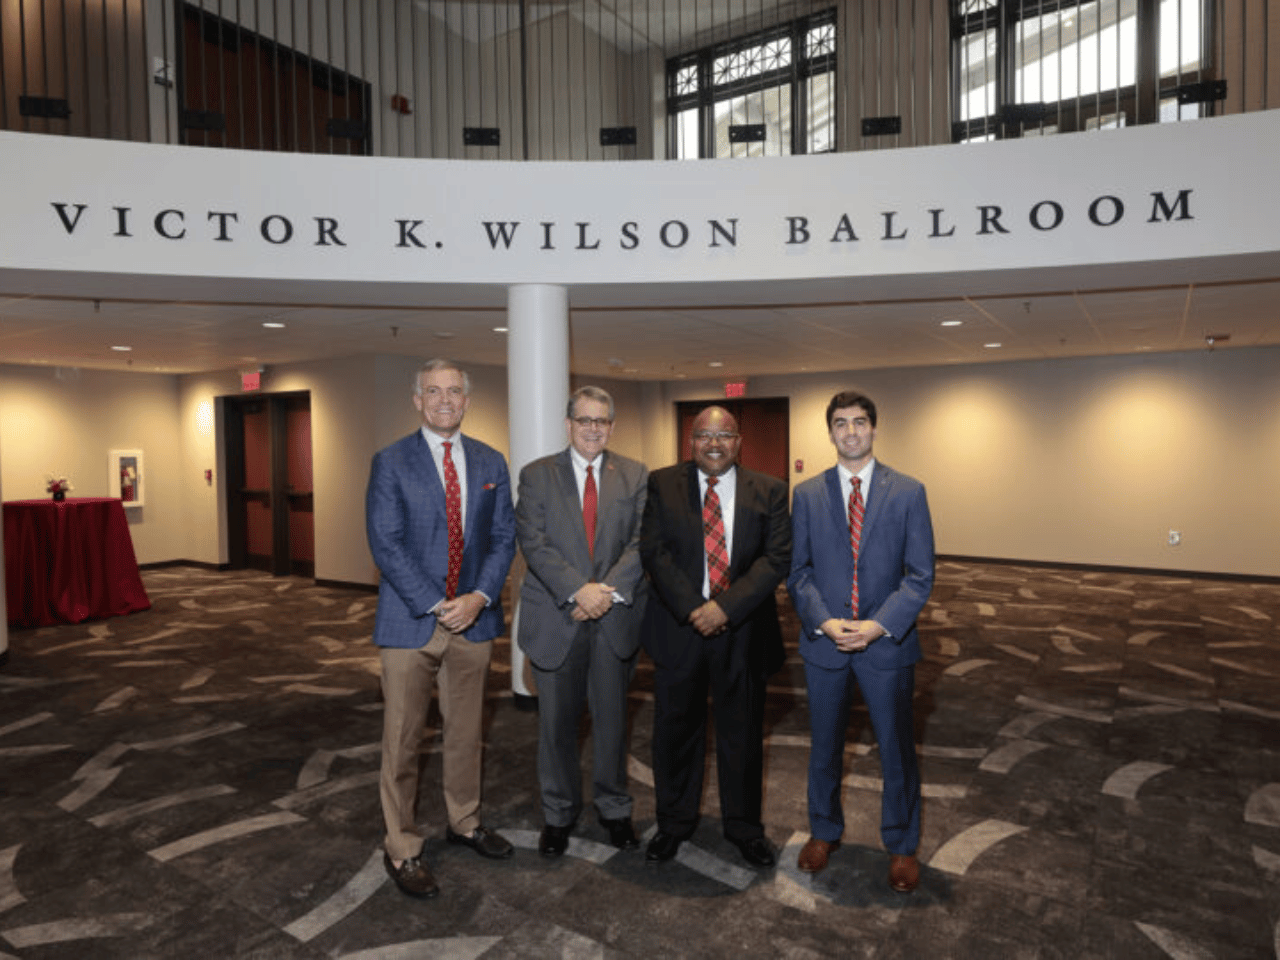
[516,448,649,669]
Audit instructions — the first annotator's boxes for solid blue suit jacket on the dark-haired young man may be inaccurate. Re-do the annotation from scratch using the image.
[787,461,933,669]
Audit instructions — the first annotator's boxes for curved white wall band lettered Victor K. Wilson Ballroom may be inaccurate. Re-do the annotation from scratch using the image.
[0,111,1280,296]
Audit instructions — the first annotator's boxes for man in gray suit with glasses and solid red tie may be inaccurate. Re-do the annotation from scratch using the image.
[516,387,648,858]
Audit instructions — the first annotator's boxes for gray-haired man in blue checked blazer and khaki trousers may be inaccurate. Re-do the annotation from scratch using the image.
[365,360,516,897]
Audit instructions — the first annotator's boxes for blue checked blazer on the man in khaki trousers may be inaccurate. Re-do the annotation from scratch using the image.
[365,430,516,648]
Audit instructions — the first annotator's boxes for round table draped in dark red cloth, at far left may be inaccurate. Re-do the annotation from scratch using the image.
[4,497,151,627]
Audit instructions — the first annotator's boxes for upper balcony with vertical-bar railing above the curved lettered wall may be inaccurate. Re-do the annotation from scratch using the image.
[0,0,1280,160]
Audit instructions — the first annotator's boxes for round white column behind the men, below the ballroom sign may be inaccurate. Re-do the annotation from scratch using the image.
[507,283,568,703]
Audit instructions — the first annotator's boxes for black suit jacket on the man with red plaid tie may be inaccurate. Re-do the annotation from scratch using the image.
[640,461,791,675]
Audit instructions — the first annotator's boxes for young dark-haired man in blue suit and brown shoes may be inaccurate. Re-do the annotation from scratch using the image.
[787,392,933,893]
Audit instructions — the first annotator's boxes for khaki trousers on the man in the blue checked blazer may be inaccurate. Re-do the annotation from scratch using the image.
[379,626,493,860]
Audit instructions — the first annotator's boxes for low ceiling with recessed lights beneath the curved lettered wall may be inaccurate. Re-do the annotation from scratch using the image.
[0,272,1280,380]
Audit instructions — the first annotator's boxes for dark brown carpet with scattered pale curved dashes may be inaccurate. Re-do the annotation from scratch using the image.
[0,562,1280,960]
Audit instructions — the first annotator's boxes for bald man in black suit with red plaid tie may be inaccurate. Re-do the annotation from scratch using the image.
[640,407,791,867]
